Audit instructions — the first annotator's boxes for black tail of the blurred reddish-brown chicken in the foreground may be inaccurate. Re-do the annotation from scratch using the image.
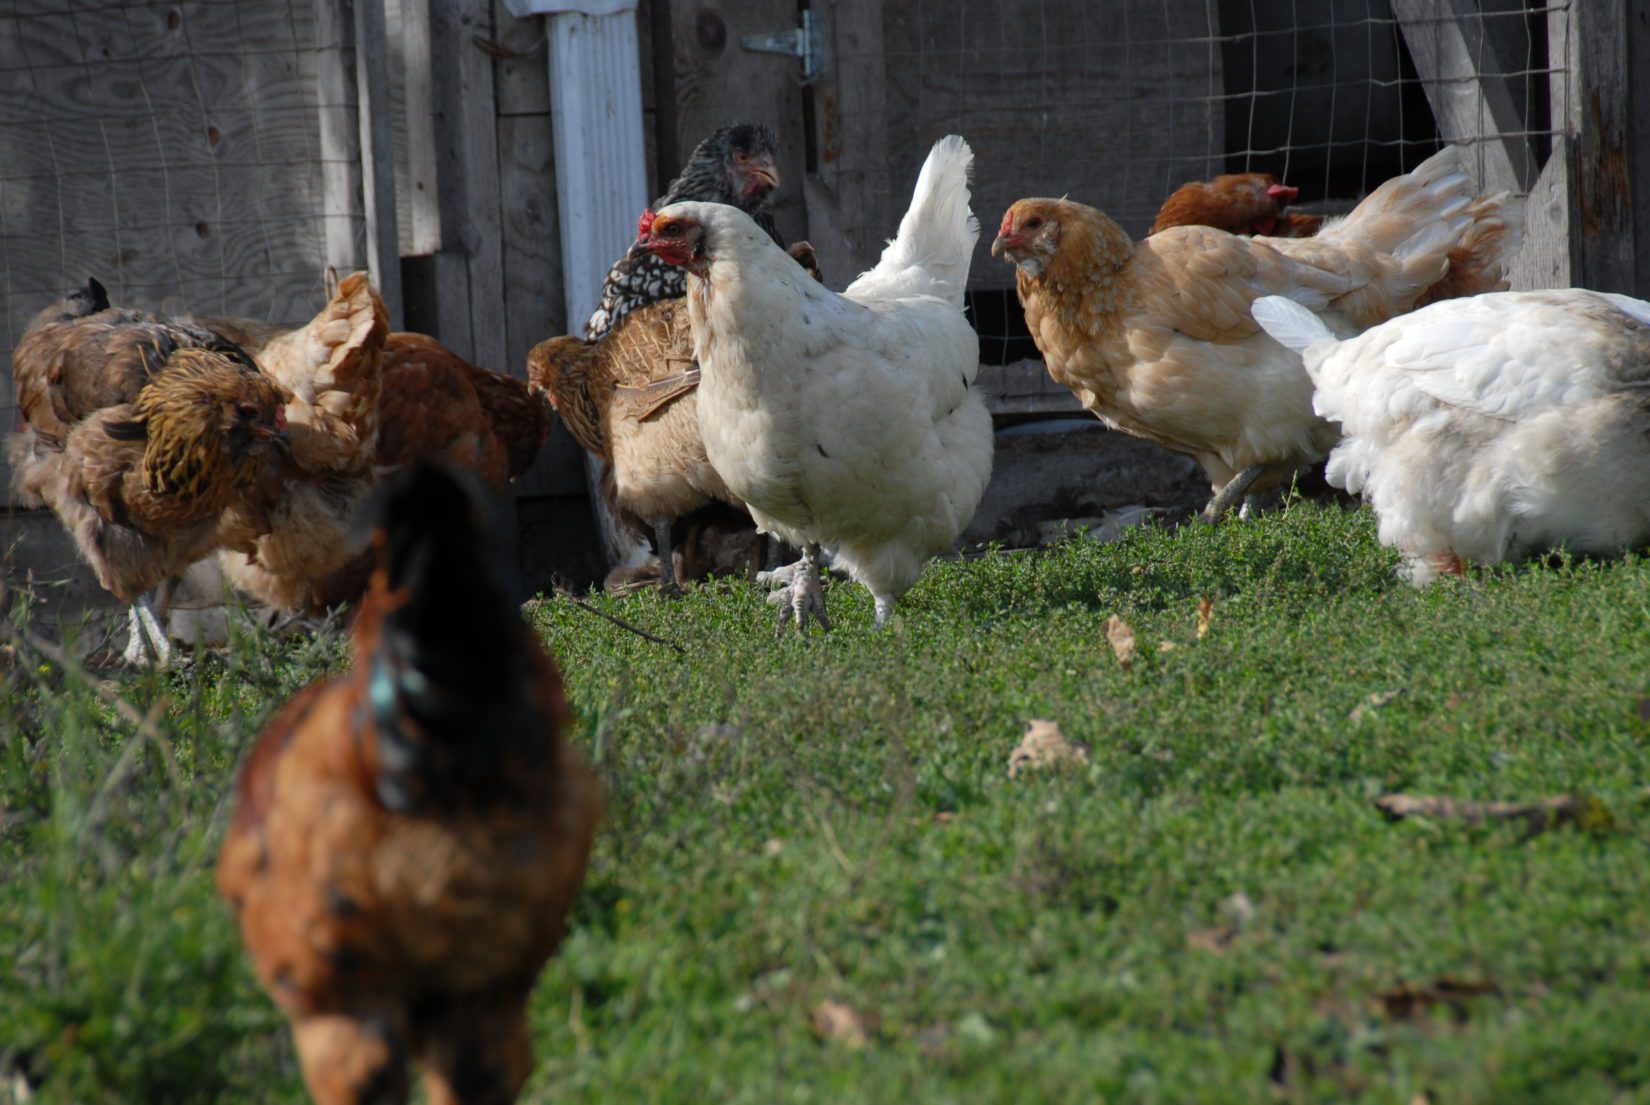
[368,462,545,811]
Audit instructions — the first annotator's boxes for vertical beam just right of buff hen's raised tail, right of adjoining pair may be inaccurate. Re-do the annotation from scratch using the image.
[353,0,403,328]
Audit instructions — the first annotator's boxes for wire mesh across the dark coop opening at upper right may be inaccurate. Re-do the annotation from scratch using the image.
[842,0,1574,363]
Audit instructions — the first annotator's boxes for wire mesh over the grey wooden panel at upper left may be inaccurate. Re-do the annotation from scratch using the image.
[0,0,365,432]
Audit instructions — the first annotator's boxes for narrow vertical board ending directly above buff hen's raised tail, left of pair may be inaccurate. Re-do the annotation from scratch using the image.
[315,0,365,272]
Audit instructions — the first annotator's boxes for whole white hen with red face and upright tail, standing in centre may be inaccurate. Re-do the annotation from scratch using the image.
[637,135,992,630]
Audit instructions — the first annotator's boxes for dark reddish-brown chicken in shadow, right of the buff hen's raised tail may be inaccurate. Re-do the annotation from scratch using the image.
[375,333,549,488]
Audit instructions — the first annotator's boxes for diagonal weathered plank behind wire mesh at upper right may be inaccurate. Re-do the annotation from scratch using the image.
[1393,0,1536,191]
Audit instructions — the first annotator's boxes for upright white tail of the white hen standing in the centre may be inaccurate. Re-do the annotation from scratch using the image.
[843,135,980,308]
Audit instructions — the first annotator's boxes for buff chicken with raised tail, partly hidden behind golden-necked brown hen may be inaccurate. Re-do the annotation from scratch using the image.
[201,272,389,612]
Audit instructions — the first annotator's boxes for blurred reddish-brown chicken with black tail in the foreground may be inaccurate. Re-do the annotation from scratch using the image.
[218,462,601,1105]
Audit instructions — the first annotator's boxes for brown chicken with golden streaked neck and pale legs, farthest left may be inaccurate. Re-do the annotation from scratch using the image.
[12,280,285,666]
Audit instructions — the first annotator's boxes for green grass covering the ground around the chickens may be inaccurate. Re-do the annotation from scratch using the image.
[0,505,1650,1105]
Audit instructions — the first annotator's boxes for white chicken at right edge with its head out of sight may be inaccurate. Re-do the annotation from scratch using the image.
[1254,289,1650,587]
